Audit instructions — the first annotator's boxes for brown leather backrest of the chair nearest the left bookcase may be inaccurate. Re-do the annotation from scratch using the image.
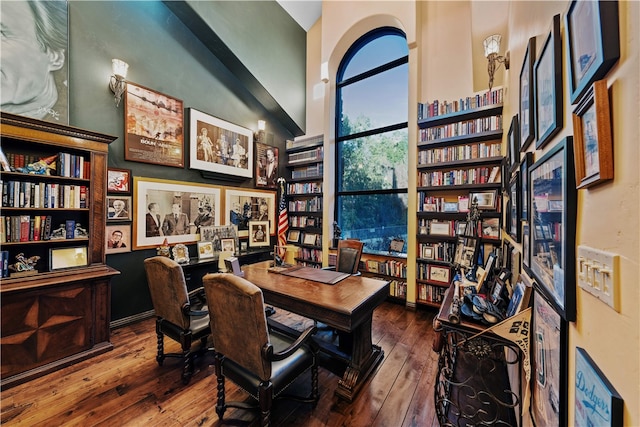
[144,256,190,329]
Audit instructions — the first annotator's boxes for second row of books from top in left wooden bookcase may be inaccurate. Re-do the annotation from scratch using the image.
[2,181,89,209]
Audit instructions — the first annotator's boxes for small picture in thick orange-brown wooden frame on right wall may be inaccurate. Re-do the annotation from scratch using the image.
[573,80,613,188]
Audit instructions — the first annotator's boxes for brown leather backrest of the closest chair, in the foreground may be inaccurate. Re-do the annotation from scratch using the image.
[202,273,271,380]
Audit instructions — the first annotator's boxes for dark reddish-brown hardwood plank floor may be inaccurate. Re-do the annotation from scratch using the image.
[0,302,438,427]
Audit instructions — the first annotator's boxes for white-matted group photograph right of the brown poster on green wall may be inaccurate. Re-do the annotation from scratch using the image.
[187,108,254,179]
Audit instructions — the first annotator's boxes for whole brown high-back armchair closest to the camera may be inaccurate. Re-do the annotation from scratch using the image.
[202,273,318,426]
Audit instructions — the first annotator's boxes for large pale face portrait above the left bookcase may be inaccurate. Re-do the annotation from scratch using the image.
[0,1,69,125]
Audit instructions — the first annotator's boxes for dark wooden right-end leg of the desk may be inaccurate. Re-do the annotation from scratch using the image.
[336,315,384,402]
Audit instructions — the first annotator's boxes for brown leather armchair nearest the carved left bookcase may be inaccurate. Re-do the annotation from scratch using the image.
[144,256,211,384]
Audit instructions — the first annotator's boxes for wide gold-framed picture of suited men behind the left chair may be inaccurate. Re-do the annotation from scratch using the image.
[133,177,222,249]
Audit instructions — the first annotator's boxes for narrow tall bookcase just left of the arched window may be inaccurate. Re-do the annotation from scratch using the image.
[286,135,324,268]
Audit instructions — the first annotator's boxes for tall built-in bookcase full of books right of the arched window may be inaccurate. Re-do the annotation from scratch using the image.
[416,89,504,307]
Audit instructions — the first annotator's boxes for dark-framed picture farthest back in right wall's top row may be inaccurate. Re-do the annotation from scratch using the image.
[519,37,536,151]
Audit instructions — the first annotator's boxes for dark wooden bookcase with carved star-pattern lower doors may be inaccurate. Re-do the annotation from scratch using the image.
[0,113,119,389]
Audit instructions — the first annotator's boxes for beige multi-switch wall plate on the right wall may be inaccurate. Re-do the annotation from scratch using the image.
[576,245,620,312]
